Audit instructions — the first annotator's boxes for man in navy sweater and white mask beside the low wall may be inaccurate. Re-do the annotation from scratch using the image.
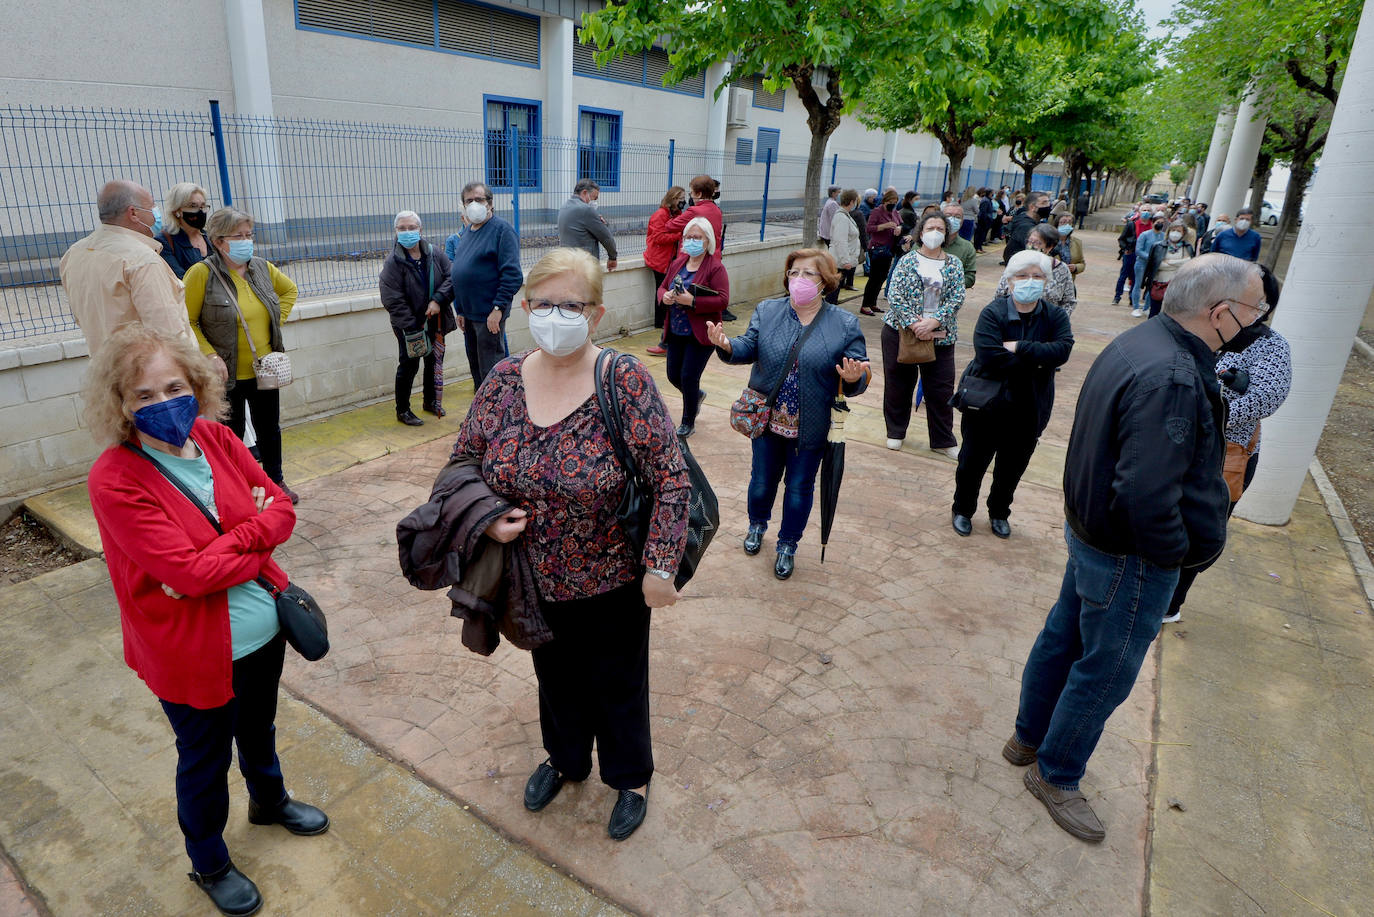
[449,181,525,388]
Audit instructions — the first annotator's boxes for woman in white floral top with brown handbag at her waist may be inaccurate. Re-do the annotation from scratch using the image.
[882,212,965,458]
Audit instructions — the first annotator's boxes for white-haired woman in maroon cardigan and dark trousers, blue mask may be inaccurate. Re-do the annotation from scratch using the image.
[658,217,730,436]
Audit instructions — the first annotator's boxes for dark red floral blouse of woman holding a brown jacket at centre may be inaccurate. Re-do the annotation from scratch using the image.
[453,353,690,602]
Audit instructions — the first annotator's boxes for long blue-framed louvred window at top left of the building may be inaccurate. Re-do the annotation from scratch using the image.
[295,0,539,67]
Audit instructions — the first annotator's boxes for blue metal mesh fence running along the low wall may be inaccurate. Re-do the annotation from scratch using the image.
[0,107,1059,341]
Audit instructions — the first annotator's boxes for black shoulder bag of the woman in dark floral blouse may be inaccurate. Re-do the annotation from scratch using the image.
[595,349,720,588]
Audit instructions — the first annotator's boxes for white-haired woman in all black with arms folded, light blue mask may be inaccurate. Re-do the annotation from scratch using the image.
[951,249,1073,538]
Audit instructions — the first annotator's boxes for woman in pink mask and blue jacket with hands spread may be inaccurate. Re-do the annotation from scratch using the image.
[706,249,872,580]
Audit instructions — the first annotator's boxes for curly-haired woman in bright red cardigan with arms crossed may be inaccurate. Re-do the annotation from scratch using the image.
[85,323,330,914]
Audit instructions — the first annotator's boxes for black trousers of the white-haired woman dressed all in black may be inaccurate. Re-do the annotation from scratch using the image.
[954,411,1040,520]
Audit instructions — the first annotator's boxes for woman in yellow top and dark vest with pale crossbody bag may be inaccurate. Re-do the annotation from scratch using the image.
[184,208,300,503]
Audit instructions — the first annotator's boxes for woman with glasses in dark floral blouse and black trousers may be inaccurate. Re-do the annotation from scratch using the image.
[453,249,690,840]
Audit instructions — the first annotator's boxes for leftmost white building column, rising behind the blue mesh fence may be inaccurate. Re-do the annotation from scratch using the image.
[224,0,286,228]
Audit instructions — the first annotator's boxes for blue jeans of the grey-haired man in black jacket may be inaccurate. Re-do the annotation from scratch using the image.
[1017,525,1179,789]
